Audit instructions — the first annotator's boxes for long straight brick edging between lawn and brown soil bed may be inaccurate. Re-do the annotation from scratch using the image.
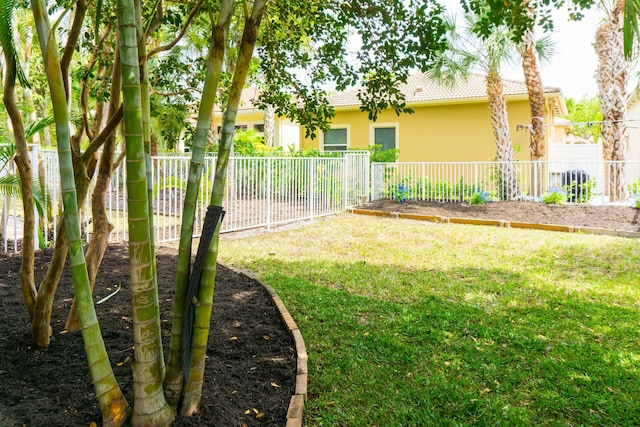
[347,208,640,238]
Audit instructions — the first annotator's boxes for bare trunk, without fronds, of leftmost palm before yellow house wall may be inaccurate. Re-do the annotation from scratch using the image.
[487,73,520,200]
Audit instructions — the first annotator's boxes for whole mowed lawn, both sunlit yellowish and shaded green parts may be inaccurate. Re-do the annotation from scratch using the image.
[220,214,640,427]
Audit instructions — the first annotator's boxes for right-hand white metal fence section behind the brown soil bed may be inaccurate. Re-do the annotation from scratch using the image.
[371,161,640,204]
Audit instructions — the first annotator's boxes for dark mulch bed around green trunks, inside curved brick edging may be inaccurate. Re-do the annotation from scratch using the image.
[0,245,296,427]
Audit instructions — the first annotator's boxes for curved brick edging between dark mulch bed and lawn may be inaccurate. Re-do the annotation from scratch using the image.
[222,264,309,427]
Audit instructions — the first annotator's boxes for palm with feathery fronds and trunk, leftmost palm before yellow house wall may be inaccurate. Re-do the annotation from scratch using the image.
[429,14,520,200]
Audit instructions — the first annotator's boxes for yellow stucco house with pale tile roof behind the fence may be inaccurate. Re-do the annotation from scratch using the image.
[222,73,567,162]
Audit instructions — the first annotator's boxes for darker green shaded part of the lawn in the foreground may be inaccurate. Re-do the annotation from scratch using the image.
[255,258,640,426]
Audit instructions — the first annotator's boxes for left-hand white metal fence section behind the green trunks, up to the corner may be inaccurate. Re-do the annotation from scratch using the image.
[0,150,369,252]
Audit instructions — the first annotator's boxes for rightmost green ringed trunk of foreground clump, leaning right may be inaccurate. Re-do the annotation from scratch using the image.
[181,0,268,415]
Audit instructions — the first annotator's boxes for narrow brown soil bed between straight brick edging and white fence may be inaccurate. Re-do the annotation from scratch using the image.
[358,200,640,232]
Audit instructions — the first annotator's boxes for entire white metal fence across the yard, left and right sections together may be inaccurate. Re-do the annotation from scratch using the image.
[5,147,640,252]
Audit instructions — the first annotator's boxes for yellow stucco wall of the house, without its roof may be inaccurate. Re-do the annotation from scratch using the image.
[302,99,552,162]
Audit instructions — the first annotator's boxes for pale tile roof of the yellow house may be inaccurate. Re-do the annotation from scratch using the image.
[329,73,560,107]
